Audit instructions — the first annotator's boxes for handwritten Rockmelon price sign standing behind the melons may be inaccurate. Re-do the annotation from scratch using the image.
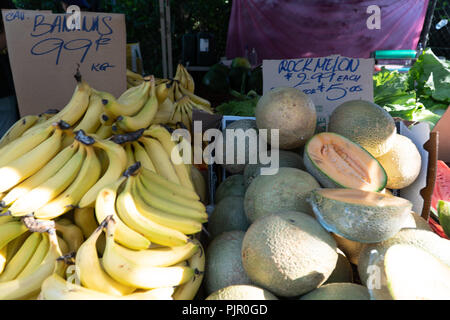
[263,55,374,130]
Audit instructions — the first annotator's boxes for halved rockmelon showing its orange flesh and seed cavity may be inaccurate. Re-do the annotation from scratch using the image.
[303,132,387,191]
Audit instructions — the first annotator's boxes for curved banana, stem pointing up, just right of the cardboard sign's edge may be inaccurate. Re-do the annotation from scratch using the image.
[116,77,158,132]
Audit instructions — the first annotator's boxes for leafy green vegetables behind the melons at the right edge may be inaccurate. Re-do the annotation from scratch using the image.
[373,49,450,129]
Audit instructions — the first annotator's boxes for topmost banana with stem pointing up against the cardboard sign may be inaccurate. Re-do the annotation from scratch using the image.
[24,77,92,135]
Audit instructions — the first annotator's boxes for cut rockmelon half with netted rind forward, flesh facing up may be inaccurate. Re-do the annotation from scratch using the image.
[308,189,412,243]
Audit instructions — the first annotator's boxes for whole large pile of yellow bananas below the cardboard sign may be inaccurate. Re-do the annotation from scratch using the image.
[0,67,208,299]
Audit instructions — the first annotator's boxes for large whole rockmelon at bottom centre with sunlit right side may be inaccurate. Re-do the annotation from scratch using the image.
[242,211,338,297]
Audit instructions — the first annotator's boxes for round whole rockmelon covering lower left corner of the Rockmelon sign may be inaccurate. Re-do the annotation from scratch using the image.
[255,87,317,149]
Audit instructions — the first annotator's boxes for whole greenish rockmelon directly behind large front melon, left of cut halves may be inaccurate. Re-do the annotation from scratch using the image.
[244,168,320,222]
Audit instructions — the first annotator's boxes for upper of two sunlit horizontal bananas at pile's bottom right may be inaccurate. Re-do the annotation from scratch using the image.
[111,234,199,267]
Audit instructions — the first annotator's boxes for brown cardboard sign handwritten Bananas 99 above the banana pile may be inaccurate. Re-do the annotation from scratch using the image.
[2,10,126,116]
